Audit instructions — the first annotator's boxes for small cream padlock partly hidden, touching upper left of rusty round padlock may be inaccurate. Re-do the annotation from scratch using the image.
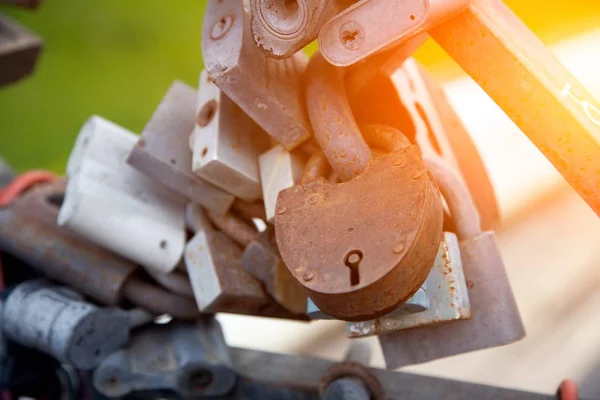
[258,145,306,223]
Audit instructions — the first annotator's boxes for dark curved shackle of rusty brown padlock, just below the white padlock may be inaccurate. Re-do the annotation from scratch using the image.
[123,278,201,320]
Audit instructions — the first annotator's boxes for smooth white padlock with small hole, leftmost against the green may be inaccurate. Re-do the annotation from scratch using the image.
[58,116,186,273]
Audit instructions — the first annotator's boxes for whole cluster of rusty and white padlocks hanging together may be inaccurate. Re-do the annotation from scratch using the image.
[7,0,600,396]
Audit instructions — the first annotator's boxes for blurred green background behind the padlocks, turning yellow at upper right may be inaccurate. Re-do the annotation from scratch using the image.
[0,0,600,172]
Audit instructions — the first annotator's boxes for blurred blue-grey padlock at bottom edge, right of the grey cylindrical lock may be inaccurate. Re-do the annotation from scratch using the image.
[93,317,237,398]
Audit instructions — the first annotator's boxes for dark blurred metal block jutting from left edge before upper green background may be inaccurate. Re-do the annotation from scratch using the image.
[0,15,42,85]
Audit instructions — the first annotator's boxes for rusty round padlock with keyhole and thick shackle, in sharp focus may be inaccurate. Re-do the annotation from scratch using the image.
[275,53,443,321]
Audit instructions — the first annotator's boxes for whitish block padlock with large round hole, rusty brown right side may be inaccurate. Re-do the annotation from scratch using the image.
[191,71,269,201]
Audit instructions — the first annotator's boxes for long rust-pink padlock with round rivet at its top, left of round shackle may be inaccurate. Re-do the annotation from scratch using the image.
[202,0,312,150]
